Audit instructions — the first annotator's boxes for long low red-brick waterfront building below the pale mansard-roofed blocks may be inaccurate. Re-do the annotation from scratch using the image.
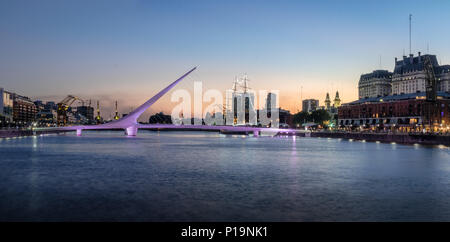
[338,92,450,131]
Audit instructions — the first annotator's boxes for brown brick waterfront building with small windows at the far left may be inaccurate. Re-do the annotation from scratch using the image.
[12,93,37,126]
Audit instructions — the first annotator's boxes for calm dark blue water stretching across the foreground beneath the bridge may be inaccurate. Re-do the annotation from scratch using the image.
[0,131,450,221]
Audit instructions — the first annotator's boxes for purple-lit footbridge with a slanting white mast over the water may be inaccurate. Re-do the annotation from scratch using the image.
[51,67,302,136]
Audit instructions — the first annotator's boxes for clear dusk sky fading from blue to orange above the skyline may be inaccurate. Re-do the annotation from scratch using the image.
[0,0,450,120]
